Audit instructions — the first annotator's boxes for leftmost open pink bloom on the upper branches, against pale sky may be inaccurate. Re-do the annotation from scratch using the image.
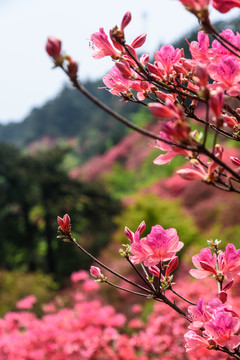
[91,28,118,59]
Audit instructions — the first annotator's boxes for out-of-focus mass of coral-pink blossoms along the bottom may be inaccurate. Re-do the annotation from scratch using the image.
[0,269,239,360]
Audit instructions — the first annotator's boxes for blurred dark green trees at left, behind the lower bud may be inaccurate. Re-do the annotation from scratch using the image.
[0,144,119,279]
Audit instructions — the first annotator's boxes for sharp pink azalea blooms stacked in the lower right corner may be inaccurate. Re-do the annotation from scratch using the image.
[184,240,240,352]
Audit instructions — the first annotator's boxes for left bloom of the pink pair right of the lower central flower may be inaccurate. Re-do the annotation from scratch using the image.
[190,248,217,279]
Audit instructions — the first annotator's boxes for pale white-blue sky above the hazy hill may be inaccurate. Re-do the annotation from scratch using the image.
[0,0,239,123]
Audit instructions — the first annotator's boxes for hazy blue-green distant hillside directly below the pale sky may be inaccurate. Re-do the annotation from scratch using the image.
[0,82,137,159]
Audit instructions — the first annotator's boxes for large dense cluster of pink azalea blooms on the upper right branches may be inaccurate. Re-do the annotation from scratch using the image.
[85,4,240,191]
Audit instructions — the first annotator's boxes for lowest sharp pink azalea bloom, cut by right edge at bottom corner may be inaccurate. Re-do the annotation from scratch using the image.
[205,311,240,350]
